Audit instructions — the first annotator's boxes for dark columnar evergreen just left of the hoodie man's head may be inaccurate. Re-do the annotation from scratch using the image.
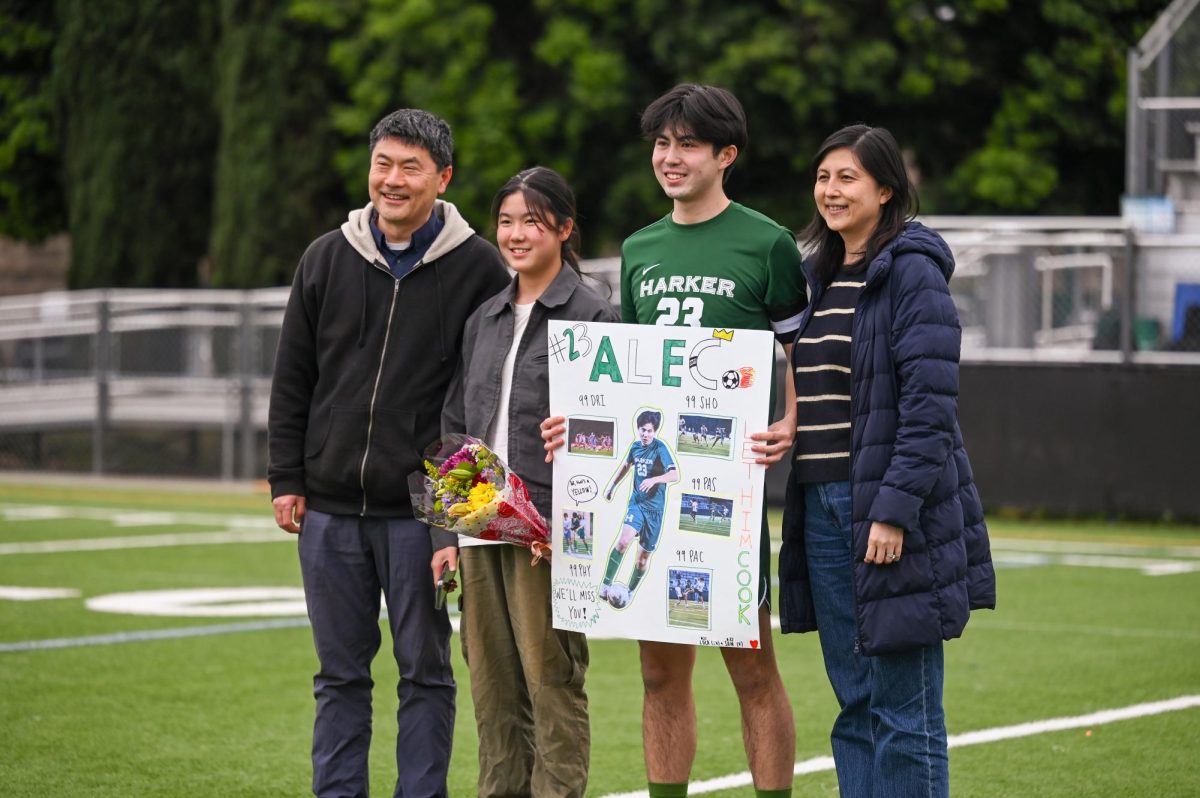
[211,0,345,288]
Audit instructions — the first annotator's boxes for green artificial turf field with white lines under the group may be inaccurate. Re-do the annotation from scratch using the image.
[0,485,1200,798]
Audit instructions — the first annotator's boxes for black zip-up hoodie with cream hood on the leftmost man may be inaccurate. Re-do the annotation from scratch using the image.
[268,200,509,542]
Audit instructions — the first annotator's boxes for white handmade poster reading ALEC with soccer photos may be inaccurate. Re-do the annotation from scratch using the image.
[547,322,774,648]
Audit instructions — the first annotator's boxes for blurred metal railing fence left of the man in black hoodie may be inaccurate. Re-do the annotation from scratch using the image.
[0,288,288,479]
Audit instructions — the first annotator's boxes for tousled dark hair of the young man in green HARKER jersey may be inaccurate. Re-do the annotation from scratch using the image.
[642,83,749,179]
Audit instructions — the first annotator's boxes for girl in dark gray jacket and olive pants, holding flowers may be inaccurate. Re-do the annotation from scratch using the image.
[433,167,619,796]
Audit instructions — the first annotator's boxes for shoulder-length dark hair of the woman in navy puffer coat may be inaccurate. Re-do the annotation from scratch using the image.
[800,125,918,286]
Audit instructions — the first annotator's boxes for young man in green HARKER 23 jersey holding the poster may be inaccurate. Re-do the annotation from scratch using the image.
[542,85,808,798]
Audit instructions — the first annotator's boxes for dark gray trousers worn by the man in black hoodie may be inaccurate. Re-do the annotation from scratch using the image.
[299,510,455,798]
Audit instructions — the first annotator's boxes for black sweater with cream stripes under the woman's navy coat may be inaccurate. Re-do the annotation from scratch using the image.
[792,270,863,482]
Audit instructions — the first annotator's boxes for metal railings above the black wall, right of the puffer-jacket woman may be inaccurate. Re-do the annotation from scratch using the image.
[923,217,1200,362]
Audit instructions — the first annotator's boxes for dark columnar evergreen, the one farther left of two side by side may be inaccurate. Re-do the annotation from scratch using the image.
[53,0,216,288]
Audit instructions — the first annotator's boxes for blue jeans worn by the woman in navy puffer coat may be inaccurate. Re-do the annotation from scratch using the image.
[804,482,949,798]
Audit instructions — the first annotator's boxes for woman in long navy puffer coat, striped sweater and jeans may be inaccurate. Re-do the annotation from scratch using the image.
[779,125,996,798]
